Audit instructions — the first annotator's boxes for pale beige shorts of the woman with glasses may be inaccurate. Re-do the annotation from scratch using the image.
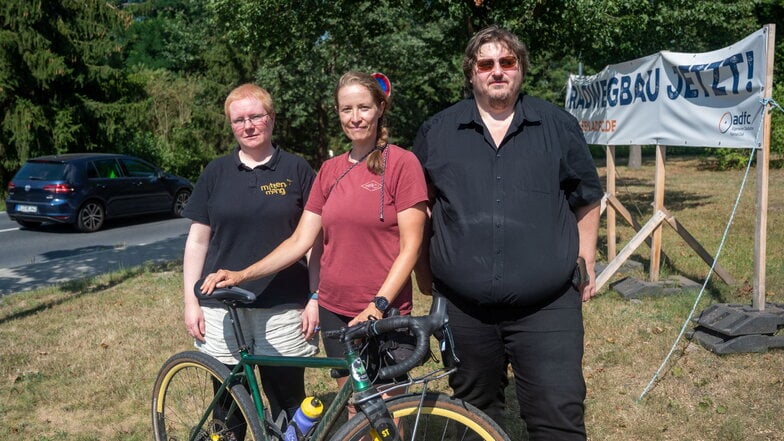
[194,305,318,365]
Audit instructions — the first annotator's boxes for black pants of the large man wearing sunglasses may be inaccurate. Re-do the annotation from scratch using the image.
[447,286,586,441]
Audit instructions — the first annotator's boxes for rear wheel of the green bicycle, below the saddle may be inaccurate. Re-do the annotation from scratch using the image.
[152,351,264,441]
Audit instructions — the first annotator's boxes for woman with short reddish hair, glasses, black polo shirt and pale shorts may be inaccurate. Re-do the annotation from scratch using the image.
[183,84,320,430]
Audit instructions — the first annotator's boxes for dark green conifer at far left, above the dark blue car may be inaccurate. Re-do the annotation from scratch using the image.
[0,0,136,183]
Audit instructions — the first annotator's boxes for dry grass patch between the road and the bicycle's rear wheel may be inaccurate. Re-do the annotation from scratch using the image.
[0,267,189,440]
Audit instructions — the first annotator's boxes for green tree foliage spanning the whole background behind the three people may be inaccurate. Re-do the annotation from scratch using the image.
[0,0,784,187]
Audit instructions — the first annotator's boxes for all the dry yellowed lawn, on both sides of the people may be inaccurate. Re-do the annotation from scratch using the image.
[0,154,784,441]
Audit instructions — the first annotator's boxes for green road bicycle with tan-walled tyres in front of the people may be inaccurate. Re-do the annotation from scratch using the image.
[152,284,509,441]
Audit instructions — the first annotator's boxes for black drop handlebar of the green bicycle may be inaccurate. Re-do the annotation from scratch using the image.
[326,294,449,380]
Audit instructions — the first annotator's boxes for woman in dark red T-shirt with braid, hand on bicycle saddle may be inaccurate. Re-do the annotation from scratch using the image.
[202,72,427,410]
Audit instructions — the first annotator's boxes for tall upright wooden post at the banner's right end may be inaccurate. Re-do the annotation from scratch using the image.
[751,24,776,311]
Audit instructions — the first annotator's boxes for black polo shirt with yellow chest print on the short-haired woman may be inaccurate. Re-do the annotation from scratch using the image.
[183,146,316,308]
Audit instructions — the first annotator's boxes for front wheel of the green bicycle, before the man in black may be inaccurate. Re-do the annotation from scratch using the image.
[332,393,509,441]
